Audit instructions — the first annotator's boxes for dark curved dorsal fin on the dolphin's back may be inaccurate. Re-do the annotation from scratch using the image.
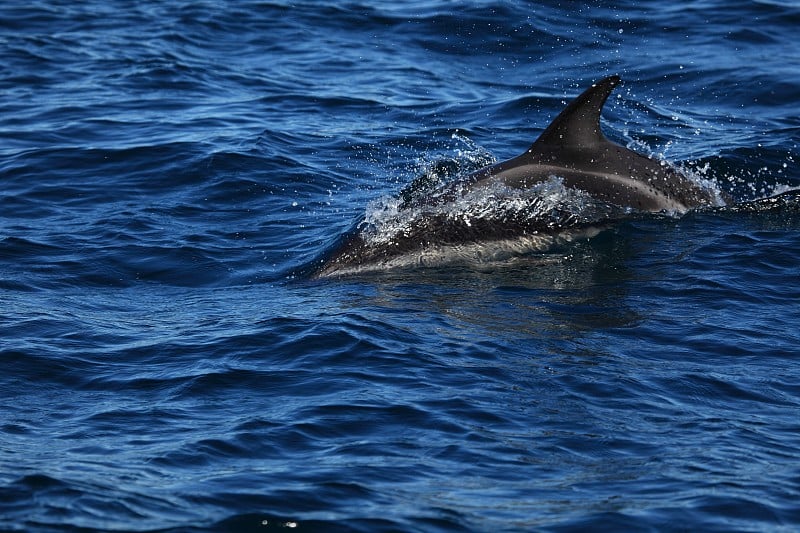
[528,75,622,157]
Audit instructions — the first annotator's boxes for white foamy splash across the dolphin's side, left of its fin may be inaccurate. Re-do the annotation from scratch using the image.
[358,151,630,267]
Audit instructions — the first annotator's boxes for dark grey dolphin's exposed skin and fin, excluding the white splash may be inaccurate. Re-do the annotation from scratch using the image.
[316,75,719,277]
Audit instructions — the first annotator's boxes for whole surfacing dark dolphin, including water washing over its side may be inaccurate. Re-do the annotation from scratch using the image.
[316,76,715,277]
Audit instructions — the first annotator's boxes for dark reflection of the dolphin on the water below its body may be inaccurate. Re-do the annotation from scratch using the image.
[328,229,641,338]
